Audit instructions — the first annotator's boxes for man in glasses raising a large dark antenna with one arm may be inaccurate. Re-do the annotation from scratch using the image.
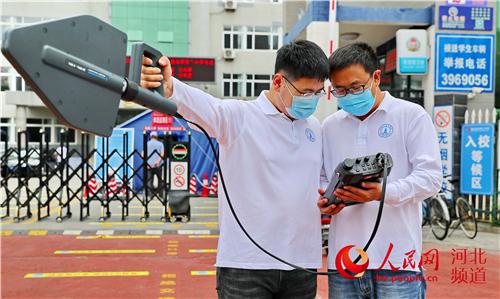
[141,41,334,298]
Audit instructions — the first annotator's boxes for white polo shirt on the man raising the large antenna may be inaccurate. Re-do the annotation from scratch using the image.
[172,79,322,270]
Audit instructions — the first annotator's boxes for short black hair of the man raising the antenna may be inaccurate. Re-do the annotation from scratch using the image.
[274,40,328,81]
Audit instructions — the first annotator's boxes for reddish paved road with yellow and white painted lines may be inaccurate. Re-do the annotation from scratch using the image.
[1,198,500,299]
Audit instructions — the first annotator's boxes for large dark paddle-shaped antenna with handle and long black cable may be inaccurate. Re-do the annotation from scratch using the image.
[2,15,388,275]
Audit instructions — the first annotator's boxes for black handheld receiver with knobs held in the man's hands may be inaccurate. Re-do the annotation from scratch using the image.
[323,153,392,206]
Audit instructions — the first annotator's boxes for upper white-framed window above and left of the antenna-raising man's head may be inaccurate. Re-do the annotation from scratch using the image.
[223,25,282,50]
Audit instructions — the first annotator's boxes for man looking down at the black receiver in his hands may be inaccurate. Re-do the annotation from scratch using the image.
[318,43,442,298]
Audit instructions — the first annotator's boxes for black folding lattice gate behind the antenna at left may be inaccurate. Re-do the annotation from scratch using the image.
[0,131,191,222]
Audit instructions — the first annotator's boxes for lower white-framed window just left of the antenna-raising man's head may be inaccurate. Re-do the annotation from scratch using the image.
[222,73,271,98]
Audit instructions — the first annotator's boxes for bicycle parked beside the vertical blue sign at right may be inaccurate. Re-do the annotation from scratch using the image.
[422,176,477,240]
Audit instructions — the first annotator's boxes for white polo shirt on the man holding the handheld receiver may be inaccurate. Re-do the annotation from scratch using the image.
[322,92,442,271]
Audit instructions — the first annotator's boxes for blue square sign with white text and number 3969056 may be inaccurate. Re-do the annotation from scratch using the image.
[434,33,495,92]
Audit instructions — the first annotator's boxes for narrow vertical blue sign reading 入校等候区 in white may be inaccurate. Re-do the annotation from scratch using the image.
[460,124,495,195]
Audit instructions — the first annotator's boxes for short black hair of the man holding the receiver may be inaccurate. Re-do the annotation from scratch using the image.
[328,42,380,75]
